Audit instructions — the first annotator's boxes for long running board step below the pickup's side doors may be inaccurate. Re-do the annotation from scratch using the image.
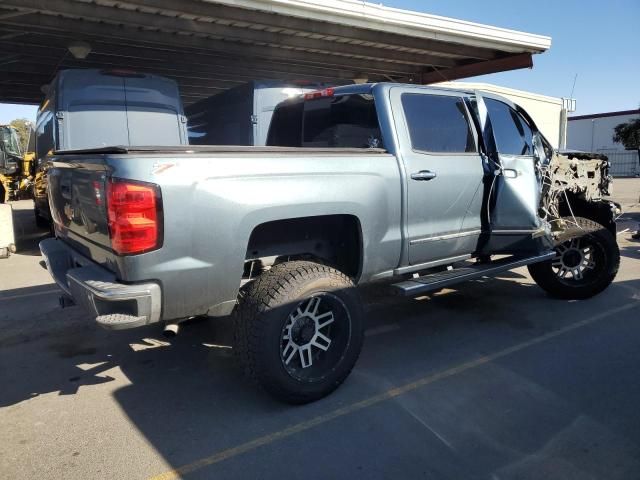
[391,252,556,297]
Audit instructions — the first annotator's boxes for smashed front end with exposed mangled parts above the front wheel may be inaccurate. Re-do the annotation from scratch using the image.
[539,152,621,241]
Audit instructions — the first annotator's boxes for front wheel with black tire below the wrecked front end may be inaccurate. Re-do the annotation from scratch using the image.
[528,217,620,300]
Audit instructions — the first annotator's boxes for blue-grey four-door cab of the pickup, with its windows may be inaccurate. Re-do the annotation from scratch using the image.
[268,84,564,262]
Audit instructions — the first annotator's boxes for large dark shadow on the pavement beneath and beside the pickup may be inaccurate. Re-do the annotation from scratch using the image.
[5,272,640,479]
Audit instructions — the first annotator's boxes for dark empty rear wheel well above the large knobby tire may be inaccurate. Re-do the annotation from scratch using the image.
[243,215,362,279]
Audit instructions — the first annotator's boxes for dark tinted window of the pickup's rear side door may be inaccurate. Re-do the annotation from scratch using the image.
[402,93,476,153]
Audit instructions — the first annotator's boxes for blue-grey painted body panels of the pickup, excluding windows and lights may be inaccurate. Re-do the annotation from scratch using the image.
[42,84,612,320]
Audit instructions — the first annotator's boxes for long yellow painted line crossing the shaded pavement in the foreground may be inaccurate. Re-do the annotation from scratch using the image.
[150,301,640,480]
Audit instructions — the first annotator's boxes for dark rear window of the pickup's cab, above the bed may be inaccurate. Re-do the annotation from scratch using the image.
[267,95,384,148]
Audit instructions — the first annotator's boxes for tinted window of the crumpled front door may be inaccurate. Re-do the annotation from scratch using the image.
[484,98,533,155]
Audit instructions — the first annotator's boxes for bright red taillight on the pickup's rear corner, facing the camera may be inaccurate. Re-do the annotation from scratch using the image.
[107,179,162,255]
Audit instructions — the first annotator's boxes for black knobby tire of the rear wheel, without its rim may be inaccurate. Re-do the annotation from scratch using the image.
[233,261,364,404]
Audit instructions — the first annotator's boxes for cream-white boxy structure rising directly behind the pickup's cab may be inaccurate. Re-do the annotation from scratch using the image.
[435,82,567,149]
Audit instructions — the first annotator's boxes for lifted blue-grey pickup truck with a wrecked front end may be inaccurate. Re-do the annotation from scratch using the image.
[40,83,620,403]
